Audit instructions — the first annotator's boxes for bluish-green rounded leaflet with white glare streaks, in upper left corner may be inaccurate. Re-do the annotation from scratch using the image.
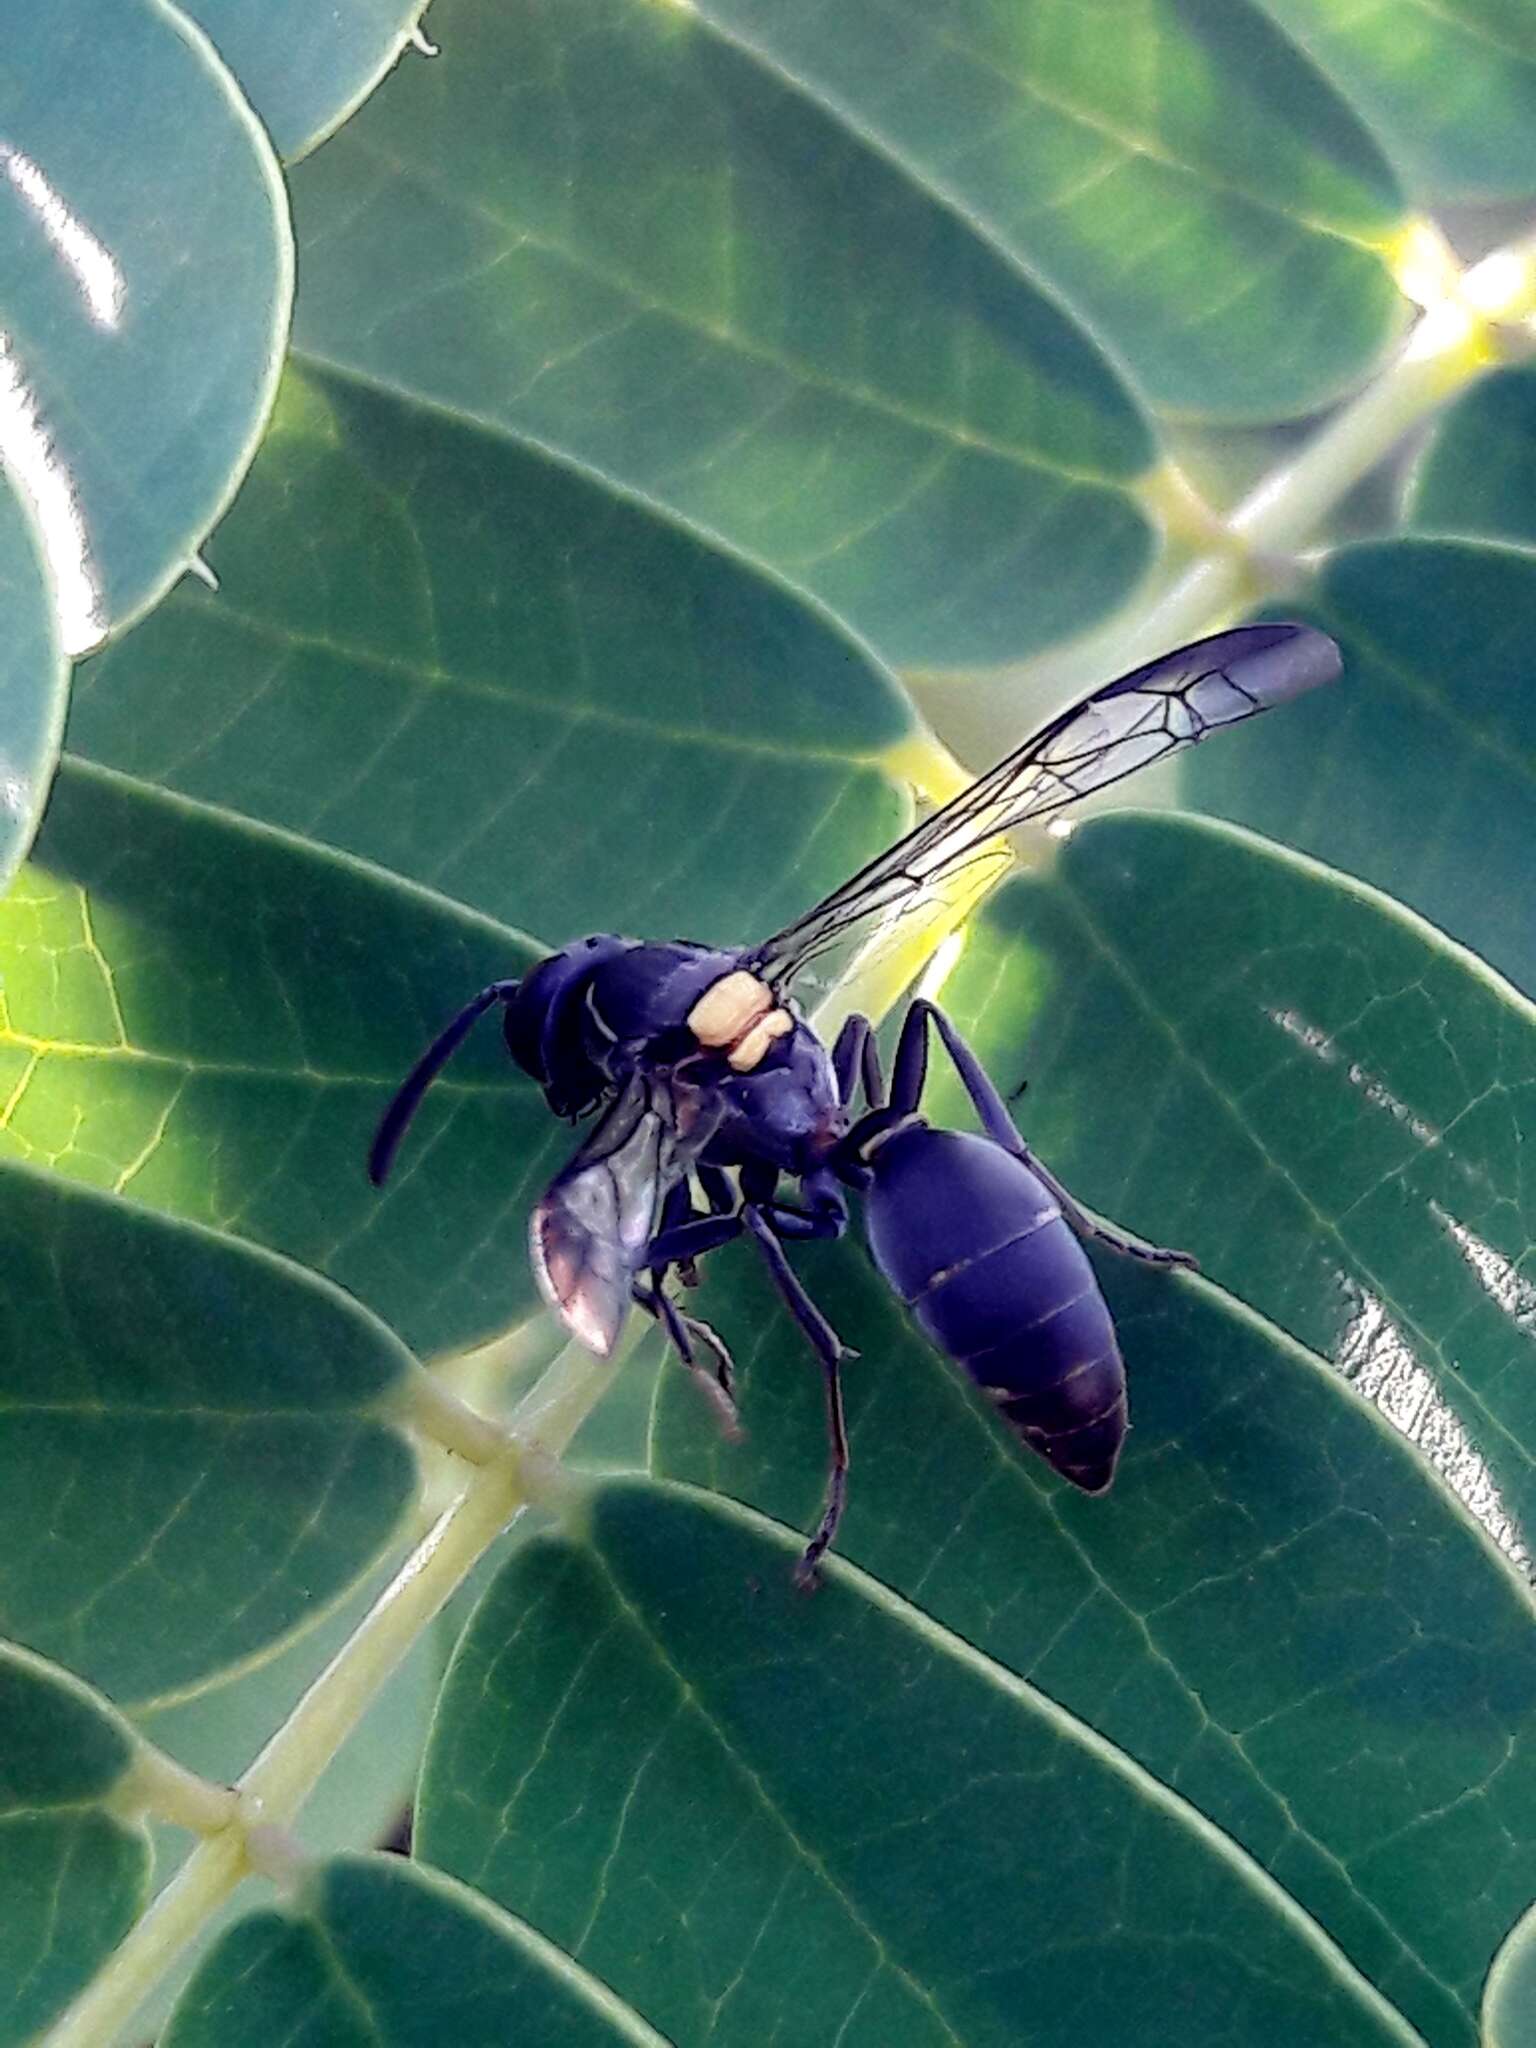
[0,0,293,653]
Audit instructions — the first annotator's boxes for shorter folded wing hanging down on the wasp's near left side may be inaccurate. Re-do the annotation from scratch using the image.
[528,1073,723,1358]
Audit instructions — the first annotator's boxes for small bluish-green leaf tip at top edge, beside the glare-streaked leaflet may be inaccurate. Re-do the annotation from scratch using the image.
[184,0,428,162]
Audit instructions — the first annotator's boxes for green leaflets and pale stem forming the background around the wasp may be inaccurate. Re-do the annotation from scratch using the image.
[0,0,1536,2048]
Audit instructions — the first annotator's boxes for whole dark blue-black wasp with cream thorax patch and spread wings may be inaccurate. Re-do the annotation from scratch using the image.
[369,625,1341,1579]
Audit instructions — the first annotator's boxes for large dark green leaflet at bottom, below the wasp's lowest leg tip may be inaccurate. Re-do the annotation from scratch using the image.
[418,1483,1411,2048]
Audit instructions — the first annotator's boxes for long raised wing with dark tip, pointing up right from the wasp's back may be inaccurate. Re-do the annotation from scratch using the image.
[743,625,1343,989]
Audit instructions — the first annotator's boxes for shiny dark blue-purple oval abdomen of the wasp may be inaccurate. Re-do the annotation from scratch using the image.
[866,1124,1126,1493]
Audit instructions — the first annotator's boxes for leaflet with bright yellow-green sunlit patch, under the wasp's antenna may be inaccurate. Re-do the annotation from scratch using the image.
[0,762,569,1350]
